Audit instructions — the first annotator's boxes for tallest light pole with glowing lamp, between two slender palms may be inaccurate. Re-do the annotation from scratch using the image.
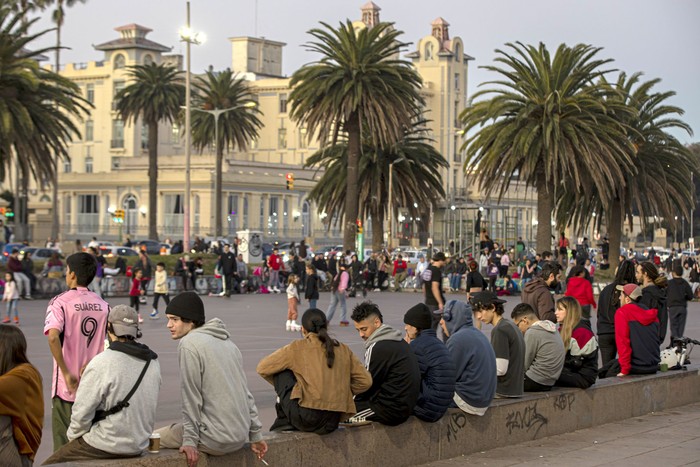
[180,2,203,252]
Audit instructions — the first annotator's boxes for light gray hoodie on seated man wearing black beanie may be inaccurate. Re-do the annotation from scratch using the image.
[178,318,262,452]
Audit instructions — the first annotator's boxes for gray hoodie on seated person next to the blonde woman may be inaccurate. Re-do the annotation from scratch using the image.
[525,320,566,386]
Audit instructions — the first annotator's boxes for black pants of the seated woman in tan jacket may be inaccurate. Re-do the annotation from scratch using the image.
[270,370,342,435]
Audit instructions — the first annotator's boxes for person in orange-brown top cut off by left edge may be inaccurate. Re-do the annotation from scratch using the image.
[0,324,44,466]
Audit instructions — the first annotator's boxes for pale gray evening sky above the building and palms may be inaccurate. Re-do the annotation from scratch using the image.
[27,0,700,143]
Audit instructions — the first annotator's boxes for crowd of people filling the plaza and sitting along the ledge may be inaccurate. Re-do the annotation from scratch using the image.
[0,231,694,466]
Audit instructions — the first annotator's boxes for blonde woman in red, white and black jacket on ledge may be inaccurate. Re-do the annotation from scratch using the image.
[554,298,598,389]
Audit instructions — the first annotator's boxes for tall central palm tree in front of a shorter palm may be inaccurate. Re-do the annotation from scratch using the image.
[290,21,423,249]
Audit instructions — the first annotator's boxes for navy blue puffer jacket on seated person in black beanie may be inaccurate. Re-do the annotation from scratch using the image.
[411,329,456,422]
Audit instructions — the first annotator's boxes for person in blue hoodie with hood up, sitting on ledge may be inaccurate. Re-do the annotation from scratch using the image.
[440,300,496,416]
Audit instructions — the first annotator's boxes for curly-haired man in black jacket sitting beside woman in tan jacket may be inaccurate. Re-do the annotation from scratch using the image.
[347,302,420,426]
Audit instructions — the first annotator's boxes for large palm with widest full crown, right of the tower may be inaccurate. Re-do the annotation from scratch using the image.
[461,42,633,251]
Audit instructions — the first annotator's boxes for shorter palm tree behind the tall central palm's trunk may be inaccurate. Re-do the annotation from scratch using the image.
[305,121,447,250]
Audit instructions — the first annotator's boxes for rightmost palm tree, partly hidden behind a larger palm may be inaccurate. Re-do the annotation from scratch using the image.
[557,73,700,269]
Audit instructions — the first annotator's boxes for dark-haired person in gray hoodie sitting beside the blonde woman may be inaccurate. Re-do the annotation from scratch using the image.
[510,303,566,392]
